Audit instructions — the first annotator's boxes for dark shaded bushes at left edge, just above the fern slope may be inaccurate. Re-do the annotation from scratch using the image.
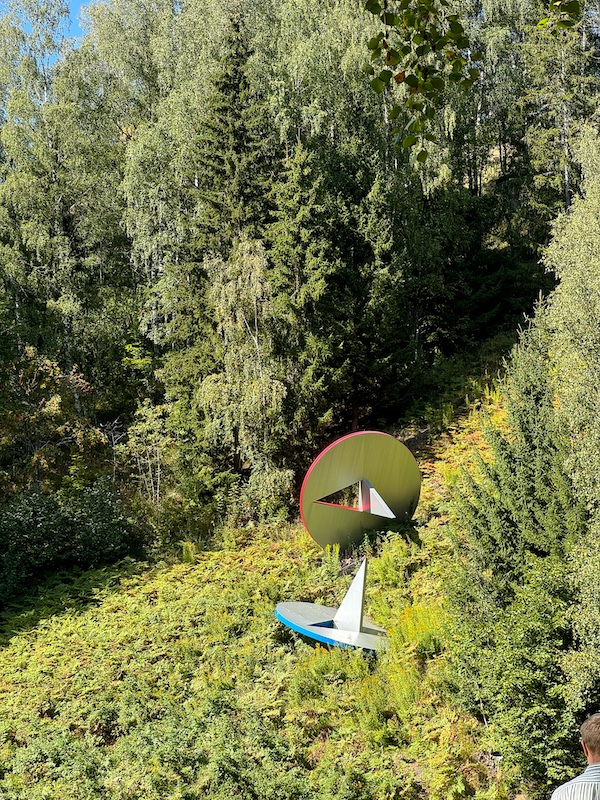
[0,480,141,603]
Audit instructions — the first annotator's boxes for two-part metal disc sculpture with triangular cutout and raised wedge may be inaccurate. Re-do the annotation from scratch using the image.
[275,431,421,651]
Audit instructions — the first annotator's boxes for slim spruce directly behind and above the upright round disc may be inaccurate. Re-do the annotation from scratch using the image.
[267,144,336,474]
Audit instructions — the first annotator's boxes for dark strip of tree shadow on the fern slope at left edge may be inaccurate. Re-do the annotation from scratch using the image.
[0,558,149,647]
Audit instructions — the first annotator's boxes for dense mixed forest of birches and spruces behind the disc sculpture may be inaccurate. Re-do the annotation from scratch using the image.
[0,2,580,509]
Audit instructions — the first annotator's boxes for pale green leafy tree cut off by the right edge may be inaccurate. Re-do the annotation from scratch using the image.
[546,128,600,716]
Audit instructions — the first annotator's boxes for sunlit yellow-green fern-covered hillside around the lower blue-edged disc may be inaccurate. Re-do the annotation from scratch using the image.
[0,396,505,800]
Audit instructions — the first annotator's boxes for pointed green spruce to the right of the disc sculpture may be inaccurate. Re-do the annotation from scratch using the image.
[457,318,585,583]
